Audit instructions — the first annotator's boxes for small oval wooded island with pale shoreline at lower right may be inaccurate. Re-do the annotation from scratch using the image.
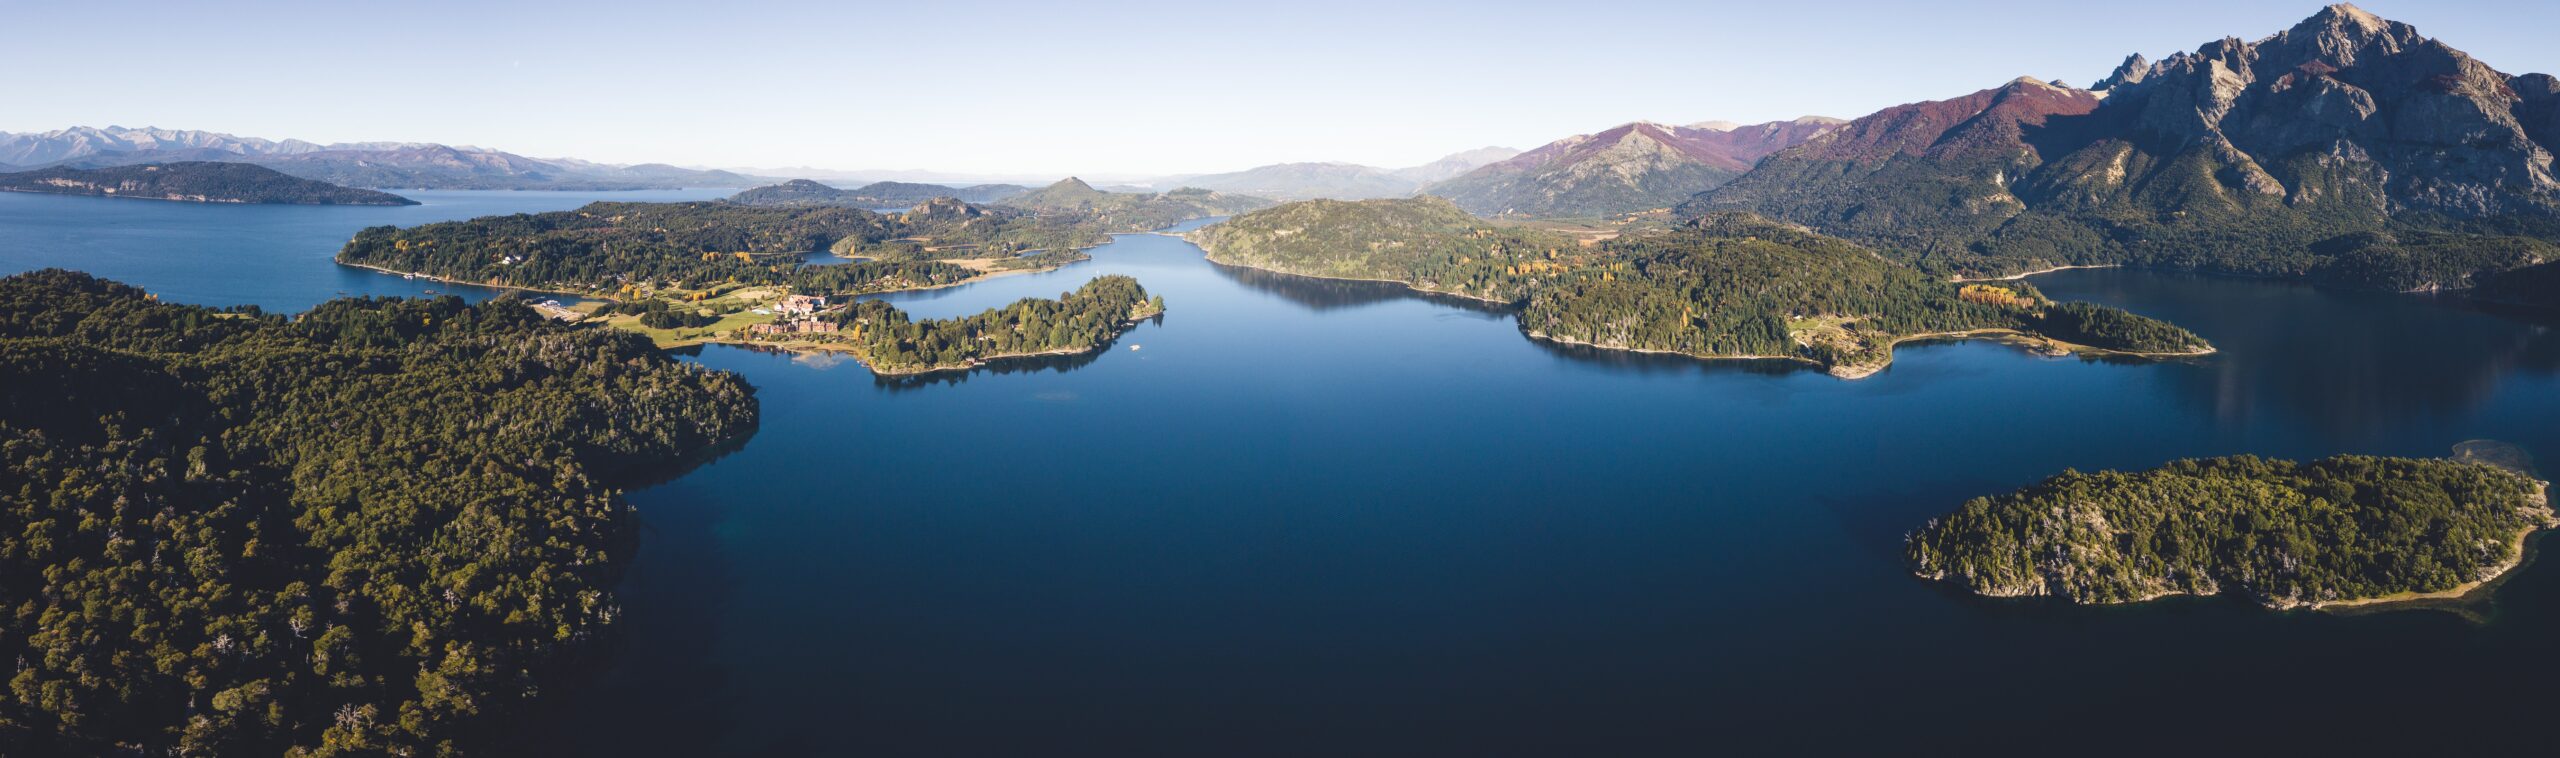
[1905,453,2555,609]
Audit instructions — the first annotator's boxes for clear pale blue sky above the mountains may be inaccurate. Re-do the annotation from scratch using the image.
[0,0,2560,179]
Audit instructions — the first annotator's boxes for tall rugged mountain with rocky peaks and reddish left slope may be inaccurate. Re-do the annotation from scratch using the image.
[1684,5,2560,289]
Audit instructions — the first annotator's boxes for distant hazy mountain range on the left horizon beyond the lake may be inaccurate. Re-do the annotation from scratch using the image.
[0,125,768,190]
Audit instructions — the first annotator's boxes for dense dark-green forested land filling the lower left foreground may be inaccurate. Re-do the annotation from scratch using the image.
[0,271,758,755]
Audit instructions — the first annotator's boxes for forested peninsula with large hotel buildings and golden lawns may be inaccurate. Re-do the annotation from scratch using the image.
[338,197,1165,374]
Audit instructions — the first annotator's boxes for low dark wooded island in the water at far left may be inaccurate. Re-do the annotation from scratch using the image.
[0,161,417,205]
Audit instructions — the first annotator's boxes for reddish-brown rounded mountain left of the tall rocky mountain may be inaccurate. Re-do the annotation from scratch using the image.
[1421,118,1838,218]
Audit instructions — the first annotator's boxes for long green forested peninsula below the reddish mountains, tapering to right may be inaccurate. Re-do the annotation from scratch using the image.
[1190,197,2212,379]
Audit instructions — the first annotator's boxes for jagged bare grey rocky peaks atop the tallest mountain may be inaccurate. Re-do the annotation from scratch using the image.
[2107,5,2560,218]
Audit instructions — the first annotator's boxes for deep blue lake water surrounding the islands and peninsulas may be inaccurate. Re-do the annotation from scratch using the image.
[0,192,2560,755]
